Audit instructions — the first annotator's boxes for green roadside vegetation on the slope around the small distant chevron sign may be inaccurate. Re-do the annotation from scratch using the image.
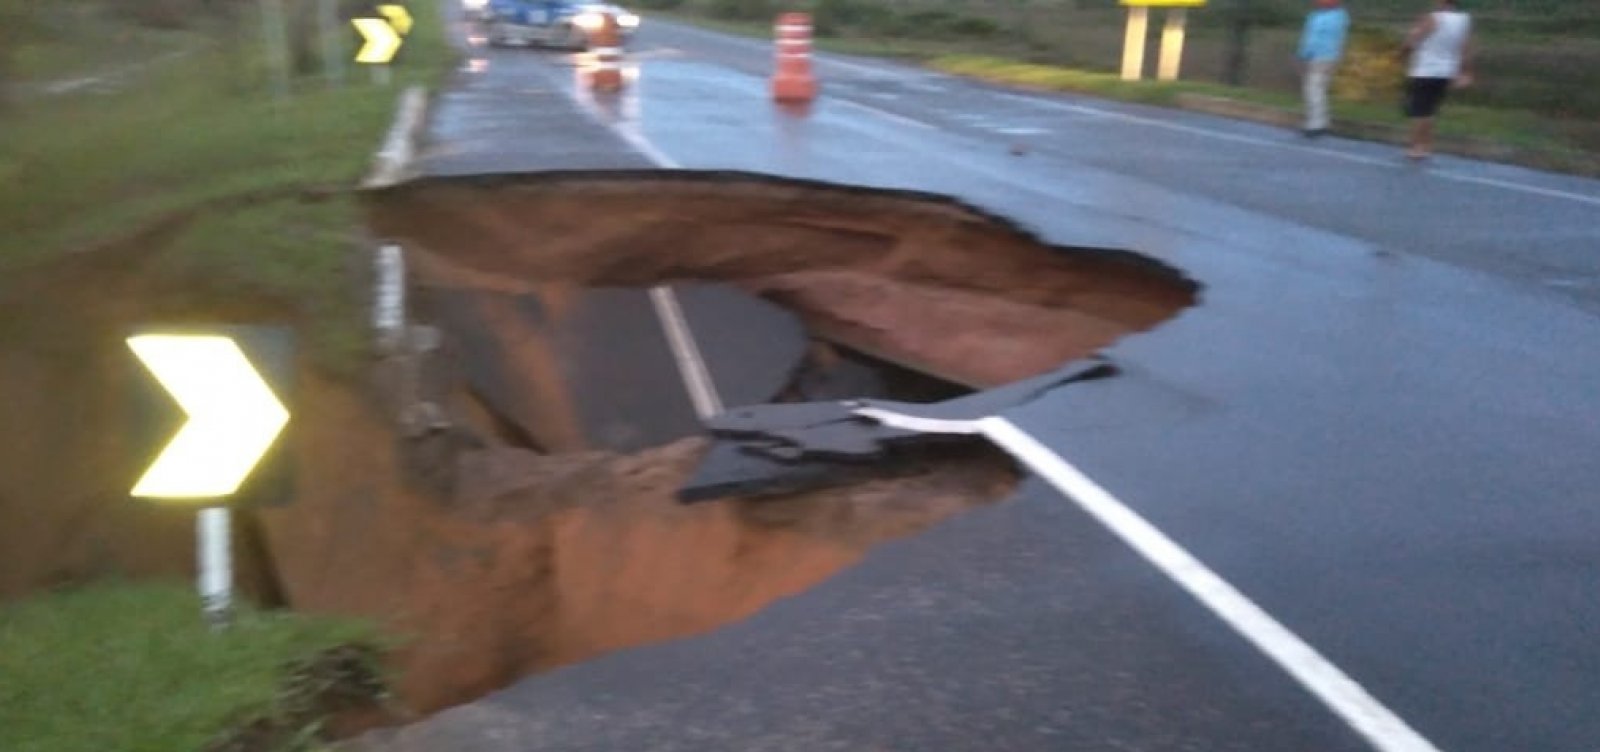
[0,0,453,370]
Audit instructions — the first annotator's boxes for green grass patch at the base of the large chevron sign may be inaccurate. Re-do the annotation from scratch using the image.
[0,584,374,752]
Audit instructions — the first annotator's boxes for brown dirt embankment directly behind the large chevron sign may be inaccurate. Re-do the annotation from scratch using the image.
[0,222,293,600]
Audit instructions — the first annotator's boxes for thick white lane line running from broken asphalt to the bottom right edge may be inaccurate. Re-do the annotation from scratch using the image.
[978,416,1438,752]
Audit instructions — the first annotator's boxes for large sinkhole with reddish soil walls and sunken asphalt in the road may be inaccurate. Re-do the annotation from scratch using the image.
[340,173,1197,726]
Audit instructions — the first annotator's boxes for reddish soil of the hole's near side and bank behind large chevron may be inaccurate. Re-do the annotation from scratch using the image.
[0,254,1014,723]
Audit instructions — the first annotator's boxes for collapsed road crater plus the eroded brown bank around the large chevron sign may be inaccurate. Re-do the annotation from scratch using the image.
[0,171,1198,728]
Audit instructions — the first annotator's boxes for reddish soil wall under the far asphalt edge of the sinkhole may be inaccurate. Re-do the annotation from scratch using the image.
[360,173,1197,387]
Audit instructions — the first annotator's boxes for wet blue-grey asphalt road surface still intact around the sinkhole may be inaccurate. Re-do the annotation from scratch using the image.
[371,10,1600,752]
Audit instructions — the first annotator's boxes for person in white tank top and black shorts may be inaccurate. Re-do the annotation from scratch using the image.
[1405,0,1472,160]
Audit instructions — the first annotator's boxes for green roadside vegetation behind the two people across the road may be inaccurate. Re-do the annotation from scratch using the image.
[642,0,1600,171]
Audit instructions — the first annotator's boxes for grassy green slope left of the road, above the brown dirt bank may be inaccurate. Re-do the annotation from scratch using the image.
[0,0,454,370]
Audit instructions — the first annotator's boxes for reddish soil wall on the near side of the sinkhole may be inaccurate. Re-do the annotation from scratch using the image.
[262,371,1014,712]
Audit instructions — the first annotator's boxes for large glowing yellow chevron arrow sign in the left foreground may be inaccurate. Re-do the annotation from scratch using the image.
[128,334,290,499]
